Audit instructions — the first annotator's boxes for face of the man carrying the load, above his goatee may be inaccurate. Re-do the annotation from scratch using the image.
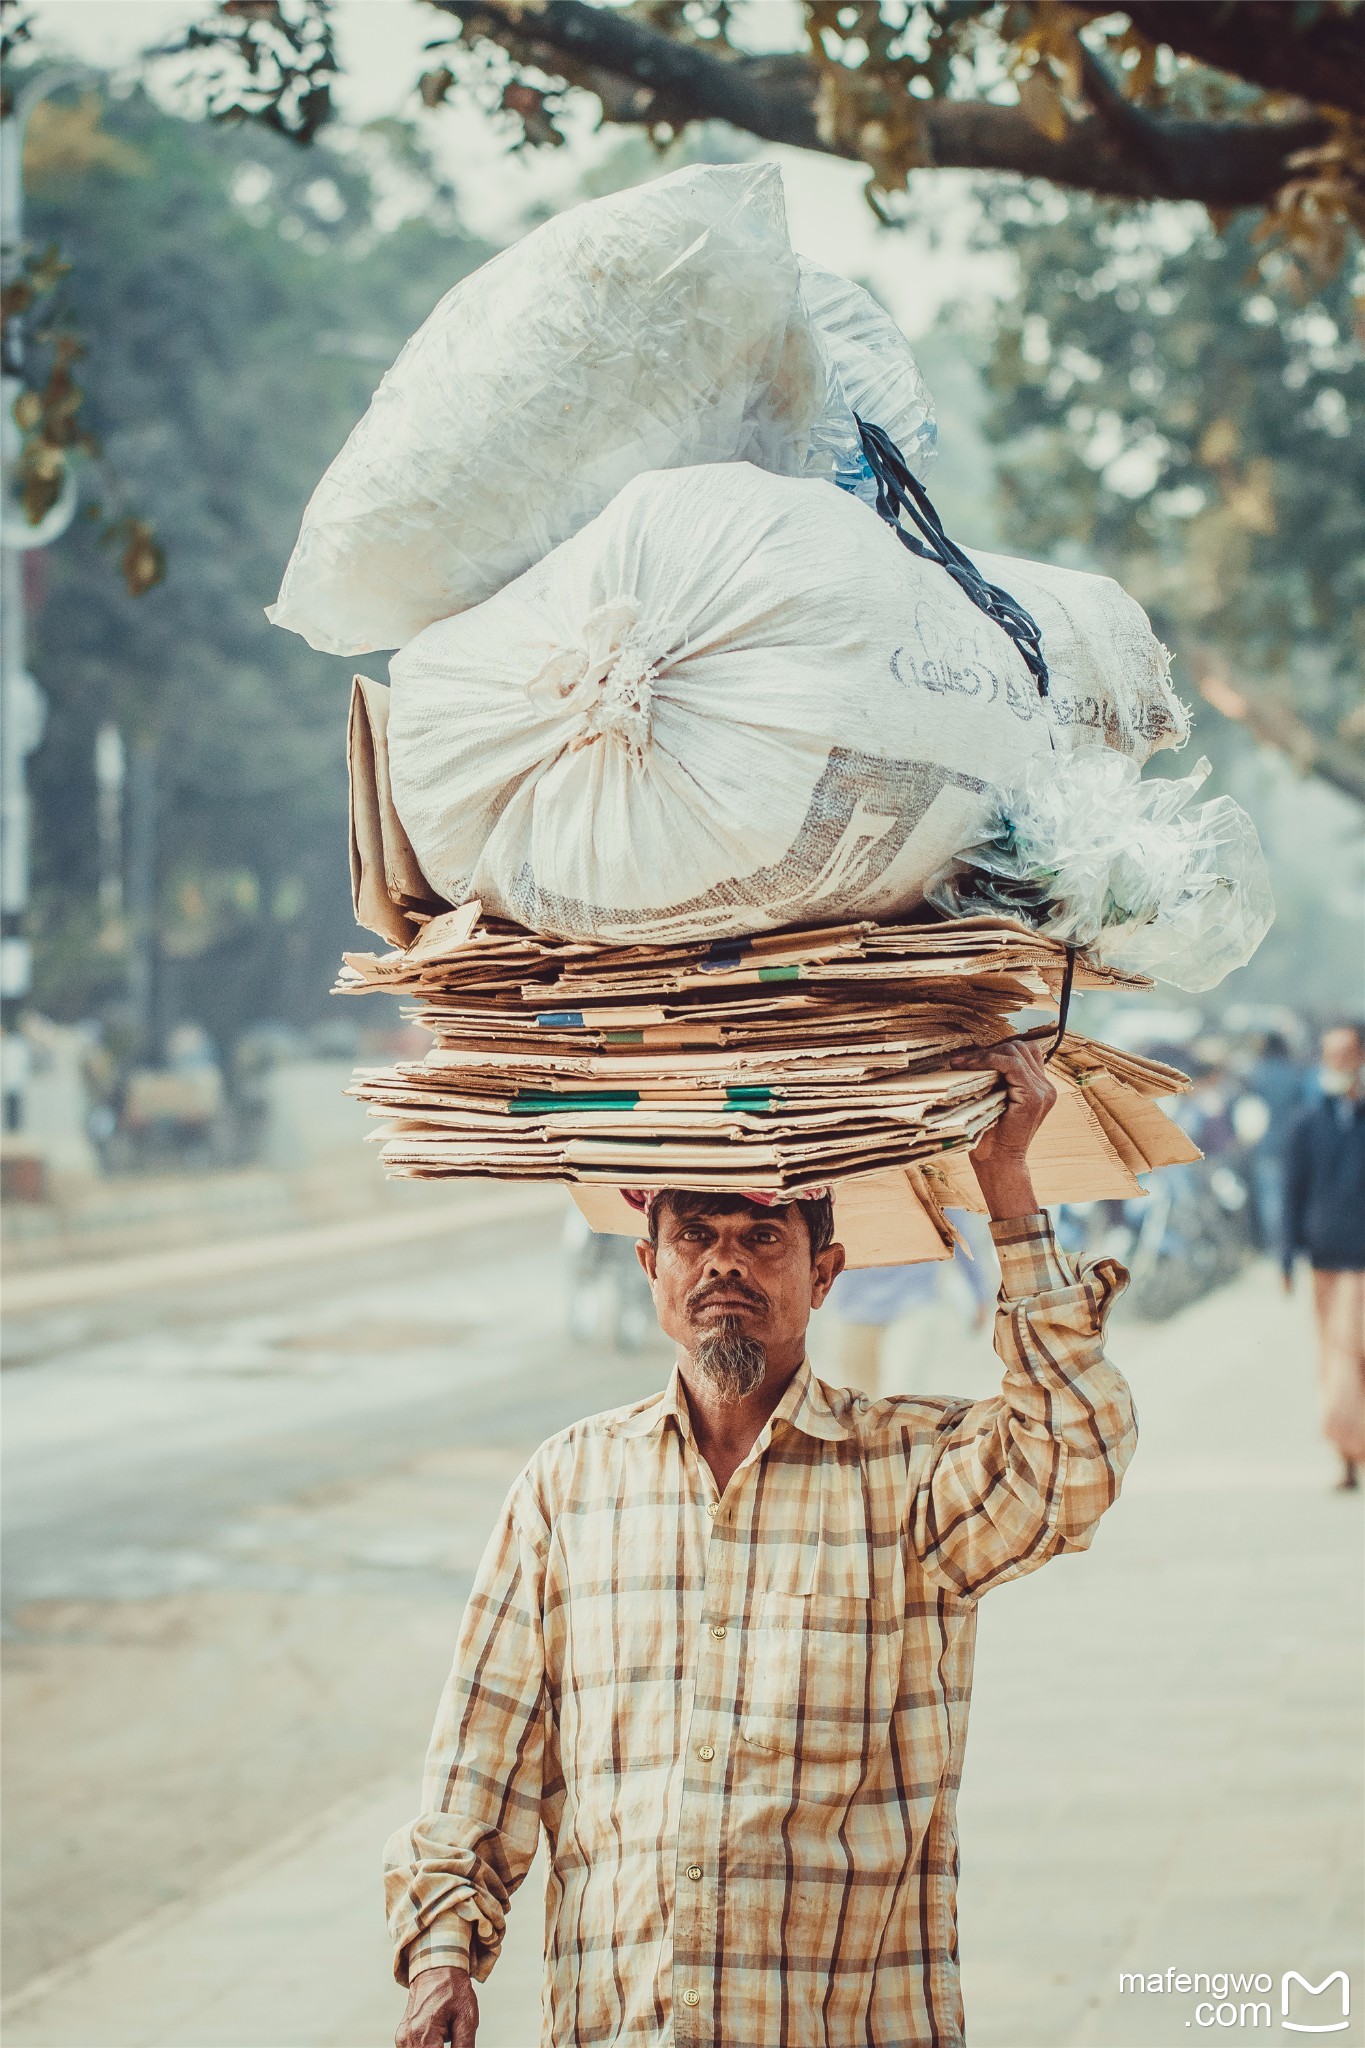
[639,1204,843,1378]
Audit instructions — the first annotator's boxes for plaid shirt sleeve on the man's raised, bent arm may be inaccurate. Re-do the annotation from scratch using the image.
[911,1210,1138,1597]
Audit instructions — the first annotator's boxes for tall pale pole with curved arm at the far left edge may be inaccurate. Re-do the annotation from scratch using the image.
[0,66,88,1133]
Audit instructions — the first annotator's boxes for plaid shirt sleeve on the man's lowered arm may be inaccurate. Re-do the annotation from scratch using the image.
[385,1483,548,1985]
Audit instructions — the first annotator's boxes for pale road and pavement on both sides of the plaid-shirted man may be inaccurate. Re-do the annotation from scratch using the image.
[4,1217,1365,2048]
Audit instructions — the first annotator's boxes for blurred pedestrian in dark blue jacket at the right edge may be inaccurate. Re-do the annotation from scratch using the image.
[1283,1024,1365,1489]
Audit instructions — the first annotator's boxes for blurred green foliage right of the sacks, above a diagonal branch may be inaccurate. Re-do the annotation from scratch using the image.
[970,188,1365,797]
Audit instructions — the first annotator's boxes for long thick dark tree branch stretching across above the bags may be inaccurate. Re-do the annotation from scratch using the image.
[428,0,1326,209]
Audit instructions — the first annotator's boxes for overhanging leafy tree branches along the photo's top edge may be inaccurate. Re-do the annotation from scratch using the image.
[139,0,1365,256]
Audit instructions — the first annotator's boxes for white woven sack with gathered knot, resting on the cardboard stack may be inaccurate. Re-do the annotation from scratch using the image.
[389,465,1179,942]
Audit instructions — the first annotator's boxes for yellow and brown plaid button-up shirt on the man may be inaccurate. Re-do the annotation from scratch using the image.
[387,1214,1136,2048]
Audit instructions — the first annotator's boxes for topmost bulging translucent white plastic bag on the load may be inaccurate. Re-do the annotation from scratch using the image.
[268,164,933,655]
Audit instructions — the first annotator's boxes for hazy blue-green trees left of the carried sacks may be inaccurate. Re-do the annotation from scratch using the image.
[29,75,487,1044]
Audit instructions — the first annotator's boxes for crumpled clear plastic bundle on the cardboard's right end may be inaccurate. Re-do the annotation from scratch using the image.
[925,745,1275,993]
